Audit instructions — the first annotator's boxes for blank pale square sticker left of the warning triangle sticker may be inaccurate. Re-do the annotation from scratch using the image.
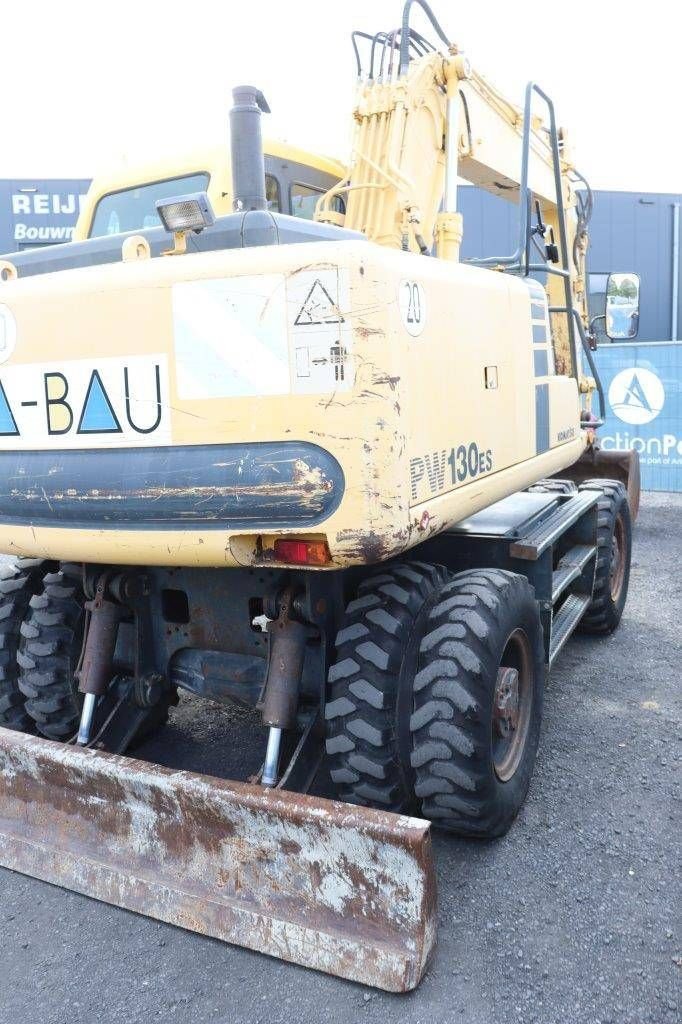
[173,273,291,398]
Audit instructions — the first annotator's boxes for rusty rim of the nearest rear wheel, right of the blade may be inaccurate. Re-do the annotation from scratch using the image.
[493,629,535,782]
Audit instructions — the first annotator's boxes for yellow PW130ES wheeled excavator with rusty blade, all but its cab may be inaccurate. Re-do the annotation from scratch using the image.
[0,0,638,991]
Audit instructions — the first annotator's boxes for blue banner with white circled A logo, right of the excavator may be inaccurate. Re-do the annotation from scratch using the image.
[596,341,682,492]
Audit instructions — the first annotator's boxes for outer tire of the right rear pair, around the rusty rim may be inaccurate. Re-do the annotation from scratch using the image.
[411,569,545,839]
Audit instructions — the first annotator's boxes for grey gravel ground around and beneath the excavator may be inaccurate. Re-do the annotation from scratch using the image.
[0,495,682,1024]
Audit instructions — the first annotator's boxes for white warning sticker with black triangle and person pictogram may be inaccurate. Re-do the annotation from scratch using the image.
[287,267,354,394]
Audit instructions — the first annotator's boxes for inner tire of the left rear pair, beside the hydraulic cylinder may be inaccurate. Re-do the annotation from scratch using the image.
[17,571,85,741]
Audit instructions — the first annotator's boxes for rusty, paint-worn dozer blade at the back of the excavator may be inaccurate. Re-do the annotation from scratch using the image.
[0,728,436,991]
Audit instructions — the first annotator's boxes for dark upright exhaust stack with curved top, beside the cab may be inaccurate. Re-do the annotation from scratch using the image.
[229,85,270,213]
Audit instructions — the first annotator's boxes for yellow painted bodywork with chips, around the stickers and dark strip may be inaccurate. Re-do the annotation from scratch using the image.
[0,236,585,567]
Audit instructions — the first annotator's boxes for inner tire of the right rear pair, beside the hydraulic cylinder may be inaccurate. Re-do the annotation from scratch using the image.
[325,562,452,813]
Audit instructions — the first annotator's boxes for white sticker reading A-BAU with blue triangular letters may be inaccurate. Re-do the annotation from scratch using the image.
[0,355,171,450]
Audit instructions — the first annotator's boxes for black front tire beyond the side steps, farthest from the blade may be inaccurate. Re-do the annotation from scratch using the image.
[579,479,632,636]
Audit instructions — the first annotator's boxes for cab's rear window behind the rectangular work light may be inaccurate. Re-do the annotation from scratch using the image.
[89,171,210,239]
